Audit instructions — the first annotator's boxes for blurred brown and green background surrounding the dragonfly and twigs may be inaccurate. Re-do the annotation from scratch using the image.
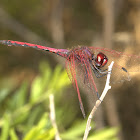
[0,0,140,140]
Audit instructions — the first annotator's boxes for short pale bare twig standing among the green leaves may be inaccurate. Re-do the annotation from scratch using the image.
[49,94,61,140]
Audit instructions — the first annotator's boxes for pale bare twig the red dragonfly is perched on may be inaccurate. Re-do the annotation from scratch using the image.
[83,61,114,140]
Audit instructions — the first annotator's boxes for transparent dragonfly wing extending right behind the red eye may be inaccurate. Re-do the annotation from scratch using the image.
[89,47,140,83]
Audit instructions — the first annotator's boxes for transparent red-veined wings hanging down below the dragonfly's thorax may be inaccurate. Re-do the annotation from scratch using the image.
[66,51,98,116]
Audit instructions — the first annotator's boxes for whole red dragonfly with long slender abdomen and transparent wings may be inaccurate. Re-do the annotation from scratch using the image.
[0,40,140,117]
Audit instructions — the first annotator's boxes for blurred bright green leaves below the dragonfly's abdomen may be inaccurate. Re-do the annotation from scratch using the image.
[0,62,118,140]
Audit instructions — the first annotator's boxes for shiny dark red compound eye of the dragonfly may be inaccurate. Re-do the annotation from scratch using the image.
[95,53,108,67]
